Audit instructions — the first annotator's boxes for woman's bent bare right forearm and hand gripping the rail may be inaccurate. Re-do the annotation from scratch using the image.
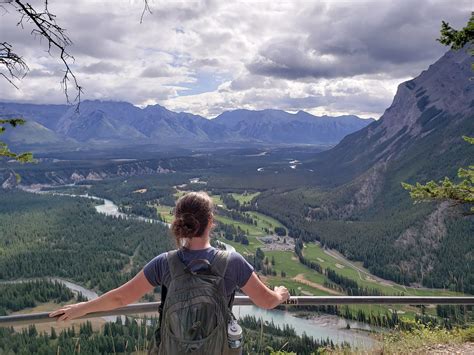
[241,272,290,309]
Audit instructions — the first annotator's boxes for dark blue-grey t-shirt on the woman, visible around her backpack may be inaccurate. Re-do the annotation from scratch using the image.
[143,247,254,298]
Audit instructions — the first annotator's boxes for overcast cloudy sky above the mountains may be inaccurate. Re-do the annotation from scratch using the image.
[0,0,473,118]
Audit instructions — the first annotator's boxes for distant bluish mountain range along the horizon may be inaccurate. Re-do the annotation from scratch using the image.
[0,101,373,146]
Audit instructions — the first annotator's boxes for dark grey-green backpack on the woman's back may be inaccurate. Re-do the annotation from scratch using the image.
[148,250,235,355]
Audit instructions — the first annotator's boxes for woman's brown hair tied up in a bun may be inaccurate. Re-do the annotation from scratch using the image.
[171,191,214,248]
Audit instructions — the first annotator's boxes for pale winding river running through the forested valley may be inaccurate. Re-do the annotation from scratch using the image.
[15,188,375,349]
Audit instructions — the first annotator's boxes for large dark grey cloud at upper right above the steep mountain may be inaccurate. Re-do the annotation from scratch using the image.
[247,0,469,79]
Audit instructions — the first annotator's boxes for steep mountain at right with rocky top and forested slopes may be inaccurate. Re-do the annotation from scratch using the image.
[258,49,474,293]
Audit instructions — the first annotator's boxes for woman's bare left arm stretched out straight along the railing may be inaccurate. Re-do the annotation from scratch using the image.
[49,270,154,321]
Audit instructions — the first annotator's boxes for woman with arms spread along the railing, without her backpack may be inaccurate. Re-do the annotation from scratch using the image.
[49,192,289,321]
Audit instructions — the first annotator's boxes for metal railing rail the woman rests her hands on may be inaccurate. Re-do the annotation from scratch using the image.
[0,296,474,327]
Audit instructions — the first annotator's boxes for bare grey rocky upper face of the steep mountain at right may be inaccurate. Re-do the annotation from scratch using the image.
[369,46,474,149]
